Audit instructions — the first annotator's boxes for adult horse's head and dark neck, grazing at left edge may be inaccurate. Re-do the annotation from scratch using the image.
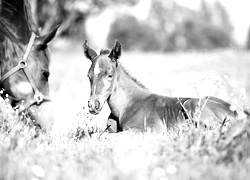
[0,0,58,129]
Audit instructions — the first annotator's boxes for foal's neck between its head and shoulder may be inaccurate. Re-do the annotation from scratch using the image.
[108,65,150,118]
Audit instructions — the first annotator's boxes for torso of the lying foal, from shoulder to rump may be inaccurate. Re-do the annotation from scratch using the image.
[120,94,237,132]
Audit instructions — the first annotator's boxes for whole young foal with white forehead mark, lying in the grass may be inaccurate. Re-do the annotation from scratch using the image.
[84,41,245,132]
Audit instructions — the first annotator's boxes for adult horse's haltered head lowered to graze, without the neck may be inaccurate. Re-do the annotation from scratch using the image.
[0,27,58,129]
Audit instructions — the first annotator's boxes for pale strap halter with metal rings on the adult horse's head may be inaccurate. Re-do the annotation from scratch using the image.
[0,32,51,113]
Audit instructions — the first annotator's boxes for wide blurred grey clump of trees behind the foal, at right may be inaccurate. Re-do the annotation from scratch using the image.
[108,0,233,51]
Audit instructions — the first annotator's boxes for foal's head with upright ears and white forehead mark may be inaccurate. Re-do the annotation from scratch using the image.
[83,40,121,114]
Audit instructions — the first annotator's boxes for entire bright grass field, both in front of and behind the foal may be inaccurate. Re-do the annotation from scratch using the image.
[0,41,250,180]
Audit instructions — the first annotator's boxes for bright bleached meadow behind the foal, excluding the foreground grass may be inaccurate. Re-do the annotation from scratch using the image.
[50,44,250,129]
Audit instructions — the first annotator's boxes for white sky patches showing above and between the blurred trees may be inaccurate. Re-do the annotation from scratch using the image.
[87,0,250,47]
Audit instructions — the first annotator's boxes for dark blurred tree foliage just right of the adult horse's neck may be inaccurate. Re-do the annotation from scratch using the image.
[31,0,138,38]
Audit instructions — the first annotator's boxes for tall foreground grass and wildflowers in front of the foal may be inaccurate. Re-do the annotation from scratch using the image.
[0,93,250,180]
